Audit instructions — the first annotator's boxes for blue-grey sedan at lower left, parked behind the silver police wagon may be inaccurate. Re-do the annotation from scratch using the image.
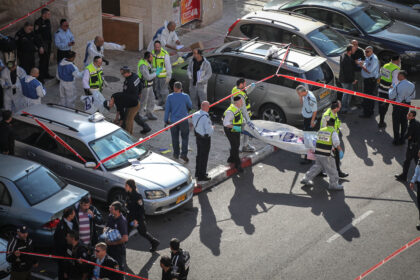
[0,154,88,246]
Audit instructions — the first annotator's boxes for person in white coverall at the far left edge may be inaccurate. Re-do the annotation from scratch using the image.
[0,62,26,113]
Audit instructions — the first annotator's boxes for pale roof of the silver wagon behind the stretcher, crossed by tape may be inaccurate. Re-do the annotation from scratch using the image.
[215,41,327,75]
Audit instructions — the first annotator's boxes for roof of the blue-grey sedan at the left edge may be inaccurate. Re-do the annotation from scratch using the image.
[0,154,40,181]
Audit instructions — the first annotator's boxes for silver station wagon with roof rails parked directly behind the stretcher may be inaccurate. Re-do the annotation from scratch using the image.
[172,41,336,124]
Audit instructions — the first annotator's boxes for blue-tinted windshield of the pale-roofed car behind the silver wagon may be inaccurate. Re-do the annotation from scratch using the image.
[308,26,347,56]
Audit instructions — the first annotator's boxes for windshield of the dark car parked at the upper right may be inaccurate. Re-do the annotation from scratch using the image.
[351,7,392,34]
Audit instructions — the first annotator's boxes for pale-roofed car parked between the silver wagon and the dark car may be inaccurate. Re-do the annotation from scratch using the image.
[226,11,348,77]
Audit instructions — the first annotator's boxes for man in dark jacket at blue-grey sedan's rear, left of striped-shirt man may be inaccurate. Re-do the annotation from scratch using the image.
[54,207,78,280]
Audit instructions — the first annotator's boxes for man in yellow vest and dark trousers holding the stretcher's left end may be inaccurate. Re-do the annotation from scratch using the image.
[223,96,244,172]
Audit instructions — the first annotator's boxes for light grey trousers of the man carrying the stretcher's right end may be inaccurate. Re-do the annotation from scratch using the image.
[303,155,339,188]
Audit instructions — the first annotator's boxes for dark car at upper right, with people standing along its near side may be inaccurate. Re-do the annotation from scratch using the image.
[264,0,420,71]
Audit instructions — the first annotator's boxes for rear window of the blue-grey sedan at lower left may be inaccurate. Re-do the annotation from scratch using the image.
[15,166,67,205]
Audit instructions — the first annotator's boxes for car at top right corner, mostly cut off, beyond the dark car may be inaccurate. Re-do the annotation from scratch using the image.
[360,0,420,26]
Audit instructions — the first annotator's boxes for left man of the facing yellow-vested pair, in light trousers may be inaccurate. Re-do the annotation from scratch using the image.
[136,51,163,122]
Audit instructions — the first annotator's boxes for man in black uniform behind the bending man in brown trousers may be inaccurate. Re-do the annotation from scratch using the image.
[120,66,152,134]
